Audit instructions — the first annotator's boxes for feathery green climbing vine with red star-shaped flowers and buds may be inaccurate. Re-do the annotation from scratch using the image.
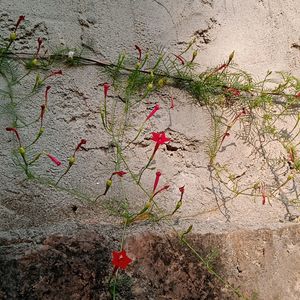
[0,16,300,299]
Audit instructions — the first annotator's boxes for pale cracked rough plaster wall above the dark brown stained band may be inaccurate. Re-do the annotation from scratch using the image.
[0,0,300,299]
